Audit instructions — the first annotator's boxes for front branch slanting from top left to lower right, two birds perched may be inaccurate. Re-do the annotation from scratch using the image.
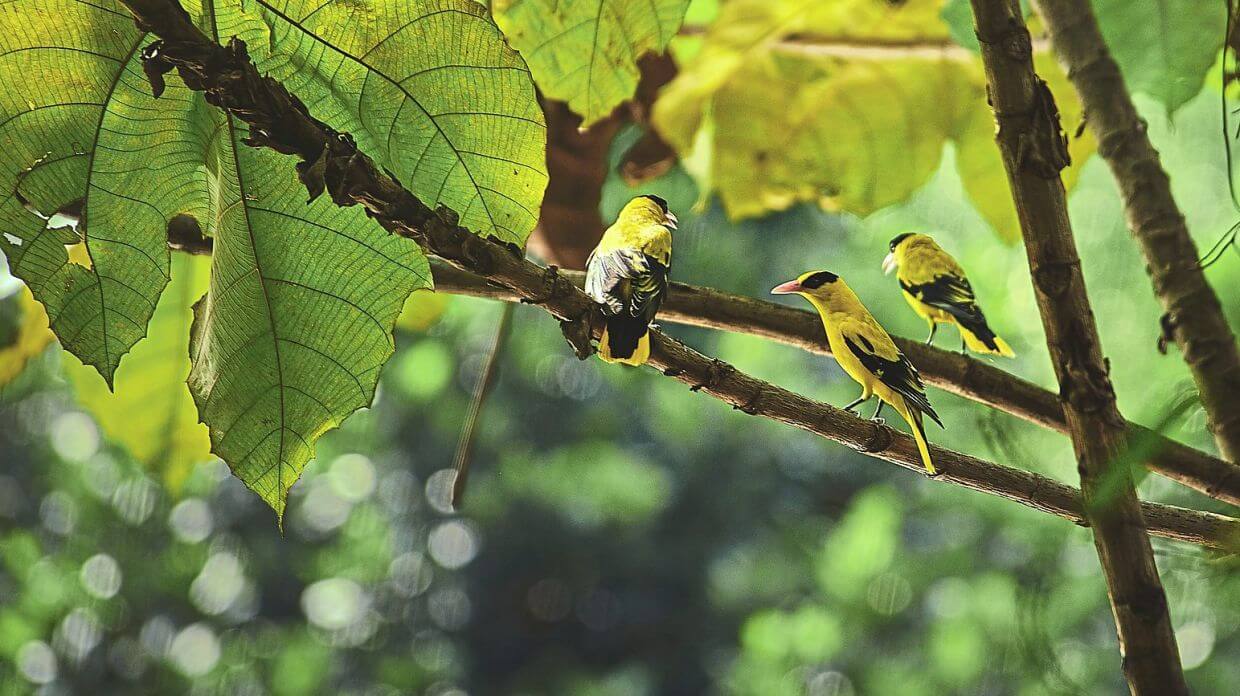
[116,0,1240,550]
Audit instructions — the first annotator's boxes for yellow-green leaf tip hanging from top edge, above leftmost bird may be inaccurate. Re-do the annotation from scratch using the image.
[492,0,689,127]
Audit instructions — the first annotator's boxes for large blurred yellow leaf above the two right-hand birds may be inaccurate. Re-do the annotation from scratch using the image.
[653,0,1094,239]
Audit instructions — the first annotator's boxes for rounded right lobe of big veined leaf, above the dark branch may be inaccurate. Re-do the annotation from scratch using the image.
[241,0,547,244]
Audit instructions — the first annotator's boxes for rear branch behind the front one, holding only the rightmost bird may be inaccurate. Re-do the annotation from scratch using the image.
[432,259,1240,505]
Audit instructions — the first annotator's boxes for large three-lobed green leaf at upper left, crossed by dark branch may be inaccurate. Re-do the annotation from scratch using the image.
[0,0,546,515]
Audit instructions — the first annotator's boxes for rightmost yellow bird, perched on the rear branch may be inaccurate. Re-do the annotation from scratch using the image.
[883,233,1016,357]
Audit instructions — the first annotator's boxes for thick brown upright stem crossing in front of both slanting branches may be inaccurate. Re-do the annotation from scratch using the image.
[971,0,1188,696]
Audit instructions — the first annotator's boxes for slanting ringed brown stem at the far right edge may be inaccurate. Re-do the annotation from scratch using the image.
[1038,0,1240,462]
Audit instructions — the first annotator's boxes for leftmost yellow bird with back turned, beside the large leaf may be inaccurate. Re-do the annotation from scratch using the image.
[585,196,678,365]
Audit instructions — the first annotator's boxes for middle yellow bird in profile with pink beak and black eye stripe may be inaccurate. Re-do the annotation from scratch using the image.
[771,270,942,476]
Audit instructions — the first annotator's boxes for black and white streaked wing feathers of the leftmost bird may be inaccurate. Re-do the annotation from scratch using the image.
[585,249,667,323]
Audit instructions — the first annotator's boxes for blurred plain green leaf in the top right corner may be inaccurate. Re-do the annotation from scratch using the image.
[1092,0,1226,112]
